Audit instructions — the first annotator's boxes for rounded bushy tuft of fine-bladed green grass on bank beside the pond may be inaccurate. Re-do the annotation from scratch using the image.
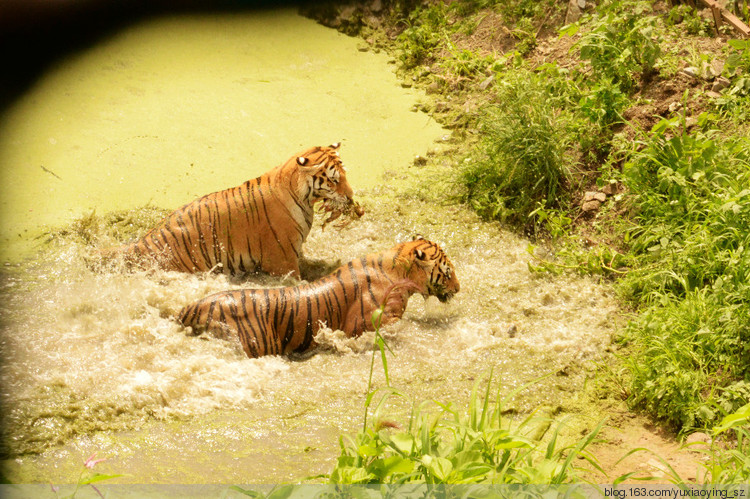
[458,72,569,230]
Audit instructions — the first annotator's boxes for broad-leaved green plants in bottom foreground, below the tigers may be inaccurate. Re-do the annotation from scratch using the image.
[330,379,601,484]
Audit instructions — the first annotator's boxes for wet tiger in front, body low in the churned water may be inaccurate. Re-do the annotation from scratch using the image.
[177,238,459,357]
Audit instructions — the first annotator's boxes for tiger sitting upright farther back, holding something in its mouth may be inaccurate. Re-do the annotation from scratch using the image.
[109,144,363,279]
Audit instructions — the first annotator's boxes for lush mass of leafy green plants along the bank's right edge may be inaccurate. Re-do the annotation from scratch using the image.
[621,117,750,430]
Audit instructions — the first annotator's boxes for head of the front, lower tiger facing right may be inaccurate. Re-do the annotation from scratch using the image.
[397,237,461,303]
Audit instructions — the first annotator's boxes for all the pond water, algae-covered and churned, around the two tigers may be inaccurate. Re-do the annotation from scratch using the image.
[0,6,616,483]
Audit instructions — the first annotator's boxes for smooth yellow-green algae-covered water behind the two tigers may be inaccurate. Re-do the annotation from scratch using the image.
[0,11,443,261]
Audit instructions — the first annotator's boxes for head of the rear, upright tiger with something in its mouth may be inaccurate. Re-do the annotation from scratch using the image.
[297,143,354,211]
